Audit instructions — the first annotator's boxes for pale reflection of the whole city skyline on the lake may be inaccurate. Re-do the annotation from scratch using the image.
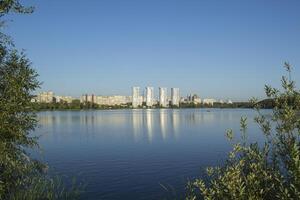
[38,109,246,143]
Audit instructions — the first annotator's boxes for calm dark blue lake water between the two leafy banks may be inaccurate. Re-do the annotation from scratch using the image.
[35,109,269,200]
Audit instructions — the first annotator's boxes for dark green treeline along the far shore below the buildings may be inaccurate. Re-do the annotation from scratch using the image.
[33,99,274,110]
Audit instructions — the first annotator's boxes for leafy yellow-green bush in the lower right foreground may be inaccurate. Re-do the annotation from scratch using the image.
[186,63,300,200]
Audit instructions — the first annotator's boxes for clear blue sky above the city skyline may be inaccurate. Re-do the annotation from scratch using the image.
[6,0,300,100]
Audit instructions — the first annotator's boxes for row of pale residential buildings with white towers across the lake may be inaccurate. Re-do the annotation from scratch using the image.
[33,87,232,108]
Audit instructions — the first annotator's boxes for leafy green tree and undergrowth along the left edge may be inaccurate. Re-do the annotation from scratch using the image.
[0,0,79,200]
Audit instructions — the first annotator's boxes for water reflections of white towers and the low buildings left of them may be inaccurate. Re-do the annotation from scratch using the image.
[38,109,184,143]
